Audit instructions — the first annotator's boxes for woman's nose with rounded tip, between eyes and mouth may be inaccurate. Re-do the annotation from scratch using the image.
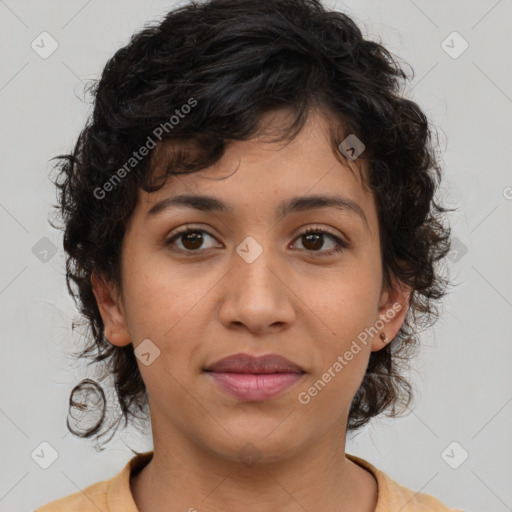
[218,248,296,335]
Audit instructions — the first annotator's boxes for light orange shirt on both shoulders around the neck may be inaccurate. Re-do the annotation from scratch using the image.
[34,452,463,512]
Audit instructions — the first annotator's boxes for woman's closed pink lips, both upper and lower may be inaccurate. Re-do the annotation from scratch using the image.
[205,354,305,401]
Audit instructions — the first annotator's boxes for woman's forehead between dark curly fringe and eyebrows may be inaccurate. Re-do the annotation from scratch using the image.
[135,111,376,235]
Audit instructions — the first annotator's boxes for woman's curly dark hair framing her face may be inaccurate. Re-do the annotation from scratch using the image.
[52,0,450,448]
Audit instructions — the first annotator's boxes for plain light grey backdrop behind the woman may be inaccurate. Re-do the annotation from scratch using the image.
[0,0,512,512]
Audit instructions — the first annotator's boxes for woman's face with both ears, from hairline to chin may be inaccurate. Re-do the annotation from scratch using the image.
[93,108,408,460]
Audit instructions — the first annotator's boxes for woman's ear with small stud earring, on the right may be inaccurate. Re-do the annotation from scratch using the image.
[372,277,411,352]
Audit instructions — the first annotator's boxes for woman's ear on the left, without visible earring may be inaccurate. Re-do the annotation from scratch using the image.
[91,272,130,347]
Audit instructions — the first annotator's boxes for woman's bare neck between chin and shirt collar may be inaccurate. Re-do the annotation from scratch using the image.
[131,414,377,512]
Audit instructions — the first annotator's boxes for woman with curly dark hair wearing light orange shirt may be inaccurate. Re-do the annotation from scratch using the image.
[38,0,462,512]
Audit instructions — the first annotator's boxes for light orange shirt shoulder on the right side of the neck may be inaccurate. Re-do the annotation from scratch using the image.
[346,453,464,512]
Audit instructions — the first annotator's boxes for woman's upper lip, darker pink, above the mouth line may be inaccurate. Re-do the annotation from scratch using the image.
[205,354,305,374]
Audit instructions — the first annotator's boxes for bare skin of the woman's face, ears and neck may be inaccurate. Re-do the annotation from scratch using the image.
[92,106,410,512]
